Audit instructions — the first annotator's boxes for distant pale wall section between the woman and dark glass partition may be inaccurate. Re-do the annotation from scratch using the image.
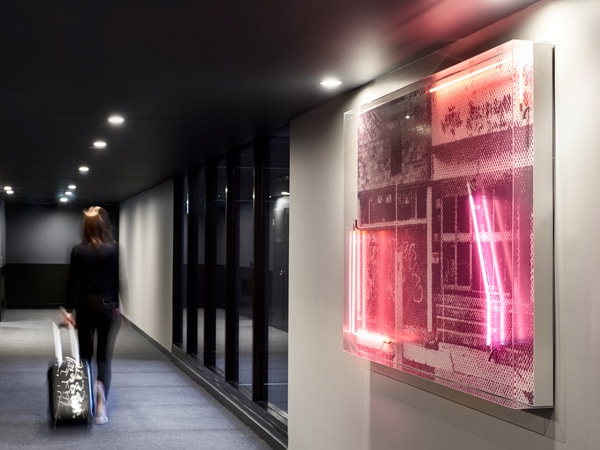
[119,181,173,351]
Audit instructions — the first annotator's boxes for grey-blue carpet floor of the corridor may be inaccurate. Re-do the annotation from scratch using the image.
[0,310,270,450]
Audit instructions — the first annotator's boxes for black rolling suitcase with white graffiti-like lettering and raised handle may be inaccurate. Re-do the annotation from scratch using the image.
[48,322,93,427]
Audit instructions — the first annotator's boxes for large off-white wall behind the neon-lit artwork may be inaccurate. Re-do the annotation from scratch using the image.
[288,0,600,450]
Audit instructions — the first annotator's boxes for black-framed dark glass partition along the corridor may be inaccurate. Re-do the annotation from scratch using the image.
[173,128,290,432]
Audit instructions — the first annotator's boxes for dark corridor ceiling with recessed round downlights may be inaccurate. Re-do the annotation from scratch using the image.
[0,0,537,206]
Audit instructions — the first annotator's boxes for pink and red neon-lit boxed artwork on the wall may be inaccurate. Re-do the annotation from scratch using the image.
[344,41,553,409]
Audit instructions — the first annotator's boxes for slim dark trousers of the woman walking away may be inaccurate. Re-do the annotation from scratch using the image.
[76,306,119,398]
